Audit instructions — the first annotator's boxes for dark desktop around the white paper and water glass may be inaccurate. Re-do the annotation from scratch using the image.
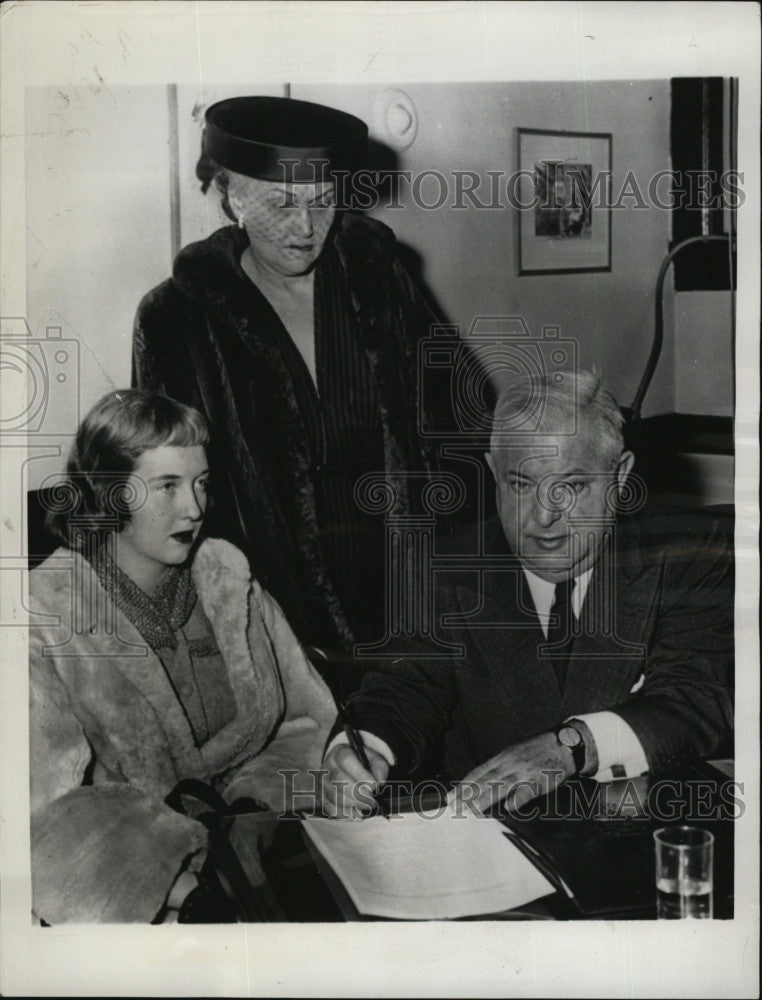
[267,764,734,922]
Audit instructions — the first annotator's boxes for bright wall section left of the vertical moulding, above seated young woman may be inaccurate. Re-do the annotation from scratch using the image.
[25,85,171,488]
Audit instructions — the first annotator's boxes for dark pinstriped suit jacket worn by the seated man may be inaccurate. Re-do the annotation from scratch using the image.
[351,510,733,780]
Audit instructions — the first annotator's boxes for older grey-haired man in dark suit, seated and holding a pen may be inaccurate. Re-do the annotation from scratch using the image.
[323,372,733,813]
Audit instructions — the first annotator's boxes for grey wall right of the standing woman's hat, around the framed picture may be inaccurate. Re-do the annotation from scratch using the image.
[292,80,675,414]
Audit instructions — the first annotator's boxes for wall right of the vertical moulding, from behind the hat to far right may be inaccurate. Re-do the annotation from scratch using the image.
[178,80,733,416]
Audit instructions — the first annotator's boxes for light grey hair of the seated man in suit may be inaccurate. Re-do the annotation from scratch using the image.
[490,369,624,465]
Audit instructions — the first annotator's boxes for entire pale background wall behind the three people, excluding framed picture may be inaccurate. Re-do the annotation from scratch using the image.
[26,80,732,485]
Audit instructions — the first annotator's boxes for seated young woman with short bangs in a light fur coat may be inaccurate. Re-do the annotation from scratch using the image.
[29,390,335,924]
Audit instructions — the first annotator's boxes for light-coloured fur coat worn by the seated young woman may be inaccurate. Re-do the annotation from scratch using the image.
[29,539,336,923]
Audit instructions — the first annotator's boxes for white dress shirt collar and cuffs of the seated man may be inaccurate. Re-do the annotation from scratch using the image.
[326,568,648,781]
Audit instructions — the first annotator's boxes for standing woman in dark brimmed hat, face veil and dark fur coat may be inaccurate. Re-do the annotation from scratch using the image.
[134,97,448,668]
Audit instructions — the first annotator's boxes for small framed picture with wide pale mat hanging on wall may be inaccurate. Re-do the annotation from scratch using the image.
[514,128,611,275]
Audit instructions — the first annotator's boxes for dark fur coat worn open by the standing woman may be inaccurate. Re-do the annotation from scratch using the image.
[133,214,448,648]
